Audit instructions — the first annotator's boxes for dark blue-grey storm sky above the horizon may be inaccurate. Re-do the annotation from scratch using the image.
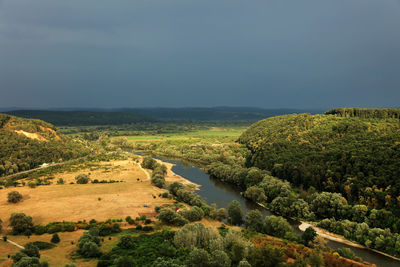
[0,0,400,108]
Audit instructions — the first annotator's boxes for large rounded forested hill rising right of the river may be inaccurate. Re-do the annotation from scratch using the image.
[239,114,400,214]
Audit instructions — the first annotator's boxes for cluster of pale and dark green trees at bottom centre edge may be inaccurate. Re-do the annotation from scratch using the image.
[98,223,285,267]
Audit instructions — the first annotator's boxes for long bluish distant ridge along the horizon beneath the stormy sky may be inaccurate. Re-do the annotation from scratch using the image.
[6,107,323,125]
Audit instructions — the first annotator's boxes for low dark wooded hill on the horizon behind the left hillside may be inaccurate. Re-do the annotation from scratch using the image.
[7,110,154,126]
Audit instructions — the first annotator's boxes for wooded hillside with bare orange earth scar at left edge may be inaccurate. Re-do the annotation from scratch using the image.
[0,114,89,176]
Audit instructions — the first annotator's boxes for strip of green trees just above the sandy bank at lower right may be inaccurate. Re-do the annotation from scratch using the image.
[318,219,400,257]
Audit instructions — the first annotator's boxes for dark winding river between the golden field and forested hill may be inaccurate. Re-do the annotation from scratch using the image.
[154,157,400,267]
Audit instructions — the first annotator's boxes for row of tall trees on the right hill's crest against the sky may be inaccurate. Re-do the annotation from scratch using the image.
[325,108,400,119]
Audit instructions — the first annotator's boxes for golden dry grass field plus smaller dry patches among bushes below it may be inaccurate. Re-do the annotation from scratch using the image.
[0,157,199,267]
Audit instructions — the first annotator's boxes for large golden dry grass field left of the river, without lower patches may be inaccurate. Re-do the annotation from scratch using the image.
[0,160,194,229]
